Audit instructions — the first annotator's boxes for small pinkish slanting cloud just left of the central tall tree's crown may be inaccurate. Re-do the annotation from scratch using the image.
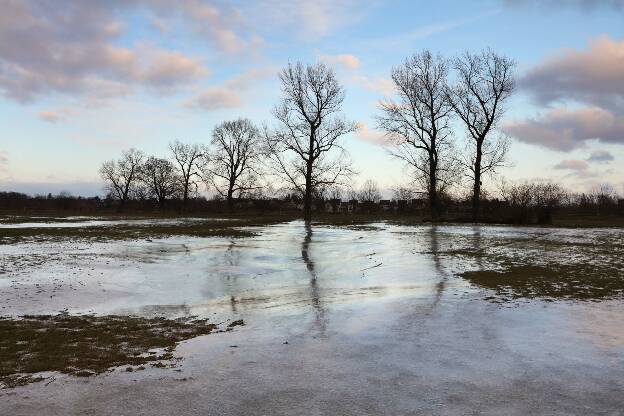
[184,67,276,111]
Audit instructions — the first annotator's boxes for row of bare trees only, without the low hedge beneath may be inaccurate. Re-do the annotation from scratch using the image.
[95,50,516,220]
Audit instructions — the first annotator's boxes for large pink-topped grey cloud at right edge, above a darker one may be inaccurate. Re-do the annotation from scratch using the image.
[520,36,624,112]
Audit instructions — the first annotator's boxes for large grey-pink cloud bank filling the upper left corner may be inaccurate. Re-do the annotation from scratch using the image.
[0,0,260,102]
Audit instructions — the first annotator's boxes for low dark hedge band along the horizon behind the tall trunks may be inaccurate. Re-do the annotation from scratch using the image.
[0,180,624,224]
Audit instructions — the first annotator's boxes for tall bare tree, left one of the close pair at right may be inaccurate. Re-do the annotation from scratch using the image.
[377,51,456,219]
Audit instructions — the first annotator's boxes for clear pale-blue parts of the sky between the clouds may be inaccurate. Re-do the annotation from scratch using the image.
[0,0,624,194]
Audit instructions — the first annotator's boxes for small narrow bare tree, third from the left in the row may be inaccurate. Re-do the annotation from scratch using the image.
[169,140,205,209]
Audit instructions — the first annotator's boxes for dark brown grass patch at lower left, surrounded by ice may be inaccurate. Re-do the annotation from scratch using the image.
[0,314,243,388]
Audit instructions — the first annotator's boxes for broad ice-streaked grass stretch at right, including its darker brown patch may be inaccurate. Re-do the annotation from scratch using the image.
[434,229,624,301]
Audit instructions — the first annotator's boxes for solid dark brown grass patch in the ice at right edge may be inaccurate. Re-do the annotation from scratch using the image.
[459,264,624,300]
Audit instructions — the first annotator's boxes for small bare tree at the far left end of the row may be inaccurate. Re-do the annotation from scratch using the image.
[100,149,145,210]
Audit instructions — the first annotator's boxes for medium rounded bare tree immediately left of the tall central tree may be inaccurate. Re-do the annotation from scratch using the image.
[206,119,262,212]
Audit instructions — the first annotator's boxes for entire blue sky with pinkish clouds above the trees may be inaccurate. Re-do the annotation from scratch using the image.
[0,0,624,196]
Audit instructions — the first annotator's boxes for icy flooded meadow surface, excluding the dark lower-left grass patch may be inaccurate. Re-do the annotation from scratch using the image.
[0,220,624,415]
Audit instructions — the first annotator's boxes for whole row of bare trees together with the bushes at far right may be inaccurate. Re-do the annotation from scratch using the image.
[4,50,618,222]
